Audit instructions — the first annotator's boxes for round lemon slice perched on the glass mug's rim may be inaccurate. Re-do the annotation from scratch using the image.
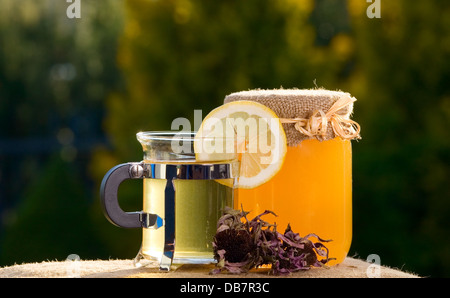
[194,101,287,188]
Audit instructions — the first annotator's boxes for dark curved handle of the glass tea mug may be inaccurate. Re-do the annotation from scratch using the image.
[100,163,163,229]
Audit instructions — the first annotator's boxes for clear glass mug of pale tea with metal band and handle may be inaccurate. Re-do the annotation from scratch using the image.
[100,132,238,270]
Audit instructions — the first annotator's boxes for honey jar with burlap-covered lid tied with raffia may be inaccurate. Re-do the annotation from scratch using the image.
[225,89,360,265]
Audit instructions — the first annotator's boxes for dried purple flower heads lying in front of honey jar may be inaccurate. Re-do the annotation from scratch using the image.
[211,208,331,275]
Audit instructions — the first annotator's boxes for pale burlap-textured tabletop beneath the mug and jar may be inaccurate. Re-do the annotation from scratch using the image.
[0,258,419,278]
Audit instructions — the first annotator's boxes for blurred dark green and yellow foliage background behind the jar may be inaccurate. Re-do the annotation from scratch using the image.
[0,0,450,277]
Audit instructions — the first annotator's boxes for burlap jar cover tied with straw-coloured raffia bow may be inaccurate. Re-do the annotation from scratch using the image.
[224,89,361,146]
